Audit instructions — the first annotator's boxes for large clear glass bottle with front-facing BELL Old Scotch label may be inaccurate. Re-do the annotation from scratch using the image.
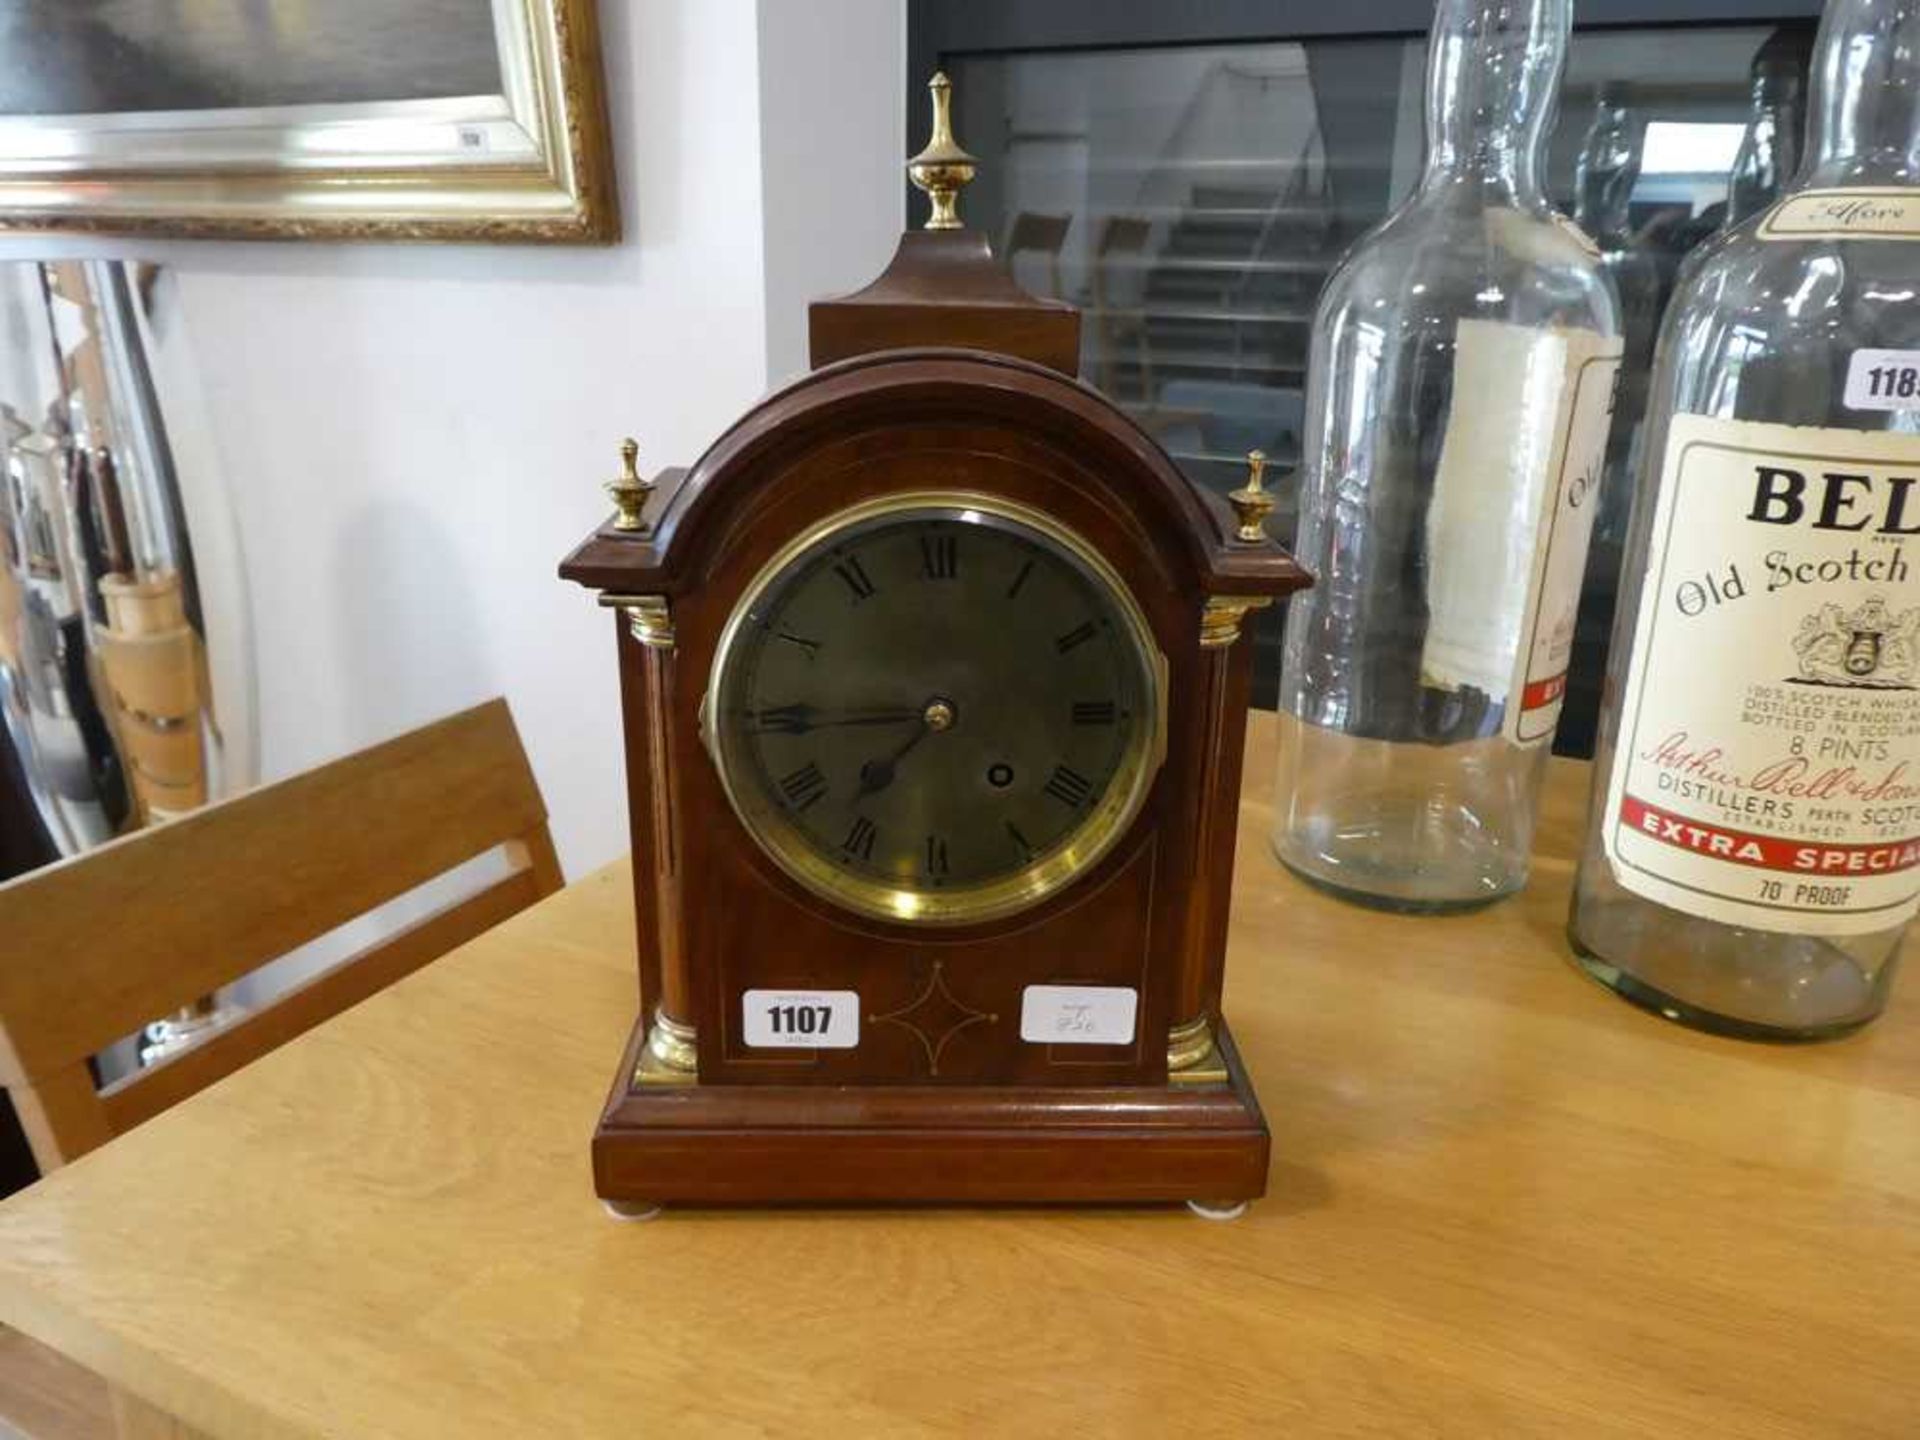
[1571,0,1920,1039]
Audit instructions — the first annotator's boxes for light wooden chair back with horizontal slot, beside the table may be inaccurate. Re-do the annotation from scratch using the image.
[0,701,561,1171]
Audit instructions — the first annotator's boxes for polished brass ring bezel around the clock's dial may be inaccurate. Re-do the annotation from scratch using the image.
[701,490,1167,925]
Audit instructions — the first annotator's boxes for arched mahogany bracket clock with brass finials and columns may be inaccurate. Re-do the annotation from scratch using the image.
[561,79,1308,1212]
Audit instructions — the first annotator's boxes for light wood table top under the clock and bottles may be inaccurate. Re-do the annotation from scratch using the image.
[0,724,1920,1440]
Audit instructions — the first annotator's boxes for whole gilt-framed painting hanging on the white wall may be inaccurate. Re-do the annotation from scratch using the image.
[0,0,620,244]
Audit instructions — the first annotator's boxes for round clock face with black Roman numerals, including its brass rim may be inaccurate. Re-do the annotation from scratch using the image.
[708,497,1160,924]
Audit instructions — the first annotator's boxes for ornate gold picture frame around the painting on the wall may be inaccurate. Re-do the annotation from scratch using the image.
[0,0,620,244]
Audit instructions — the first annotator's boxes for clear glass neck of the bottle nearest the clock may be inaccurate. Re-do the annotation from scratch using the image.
[1421,0,1566,202]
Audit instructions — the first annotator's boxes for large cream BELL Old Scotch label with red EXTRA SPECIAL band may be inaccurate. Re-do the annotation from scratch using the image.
[1603,415,1920,935]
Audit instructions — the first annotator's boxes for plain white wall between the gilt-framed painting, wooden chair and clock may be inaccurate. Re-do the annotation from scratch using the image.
[0,0,904,876]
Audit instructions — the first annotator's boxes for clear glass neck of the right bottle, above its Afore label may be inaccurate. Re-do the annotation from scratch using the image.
[1797,0,1920,190]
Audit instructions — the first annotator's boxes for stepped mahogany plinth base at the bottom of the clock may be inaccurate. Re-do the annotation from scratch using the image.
[593,1023,1269,1206]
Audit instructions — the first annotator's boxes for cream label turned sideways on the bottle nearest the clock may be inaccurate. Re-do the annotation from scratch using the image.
[1421,321,1620,745]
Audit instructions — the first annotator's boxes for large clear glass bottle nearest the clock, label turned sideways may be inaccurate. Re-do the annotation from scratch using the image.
[1275,0,1620,910]
